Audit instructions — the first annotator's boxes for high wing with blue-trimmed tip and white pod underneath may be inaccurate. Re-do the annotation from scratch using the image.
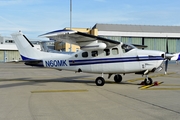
[40,30,120,50]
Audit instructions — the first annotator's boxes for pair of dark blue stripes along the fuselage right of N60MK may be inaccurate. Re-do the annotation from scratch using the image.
[69,56,163,66]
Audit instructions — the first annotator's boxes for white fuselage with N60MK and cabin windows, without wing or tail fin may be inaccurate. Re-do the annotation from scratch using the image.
[43,45,164,74]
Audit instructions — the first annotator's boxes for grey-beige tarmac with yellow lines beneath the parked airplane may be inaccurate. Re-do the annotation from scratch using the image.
[0,63,180,120]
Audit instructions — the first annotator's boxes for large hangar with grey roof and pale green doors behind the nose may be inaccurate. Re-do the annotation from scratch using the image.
[92,24,180,53]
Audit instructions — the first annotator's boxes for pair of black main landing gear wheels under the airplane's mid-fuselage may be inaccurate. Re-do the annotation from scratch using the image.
[95,74,122,86]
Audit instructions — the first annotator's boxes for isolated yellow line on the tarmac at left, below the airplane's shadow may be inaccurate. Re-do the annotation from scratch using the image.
[31,89,88,93]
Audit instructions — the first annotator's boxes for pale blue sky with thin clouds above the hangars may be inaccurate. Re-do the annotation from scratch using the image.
[0,0,180,39]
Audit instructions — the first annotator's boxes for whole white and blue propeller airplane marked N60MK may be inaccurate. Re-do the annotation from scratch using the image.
[12,30,173,86]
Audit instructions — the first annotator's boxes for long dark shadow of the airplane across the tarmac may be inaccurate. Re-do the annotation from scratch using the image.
[0,76,139,89]
